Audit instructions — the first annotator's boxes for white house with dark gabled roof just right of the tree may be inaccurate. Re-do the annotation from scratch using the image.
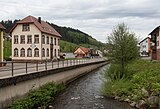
[139,37,151,56]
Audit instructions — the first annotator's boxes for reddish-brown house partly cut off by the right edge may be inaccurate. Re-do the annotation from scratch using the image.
[149,26,160,60]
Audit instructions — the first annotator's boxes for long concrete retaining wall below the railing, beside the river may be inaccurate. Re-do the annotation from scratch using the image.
[0,61,106,109]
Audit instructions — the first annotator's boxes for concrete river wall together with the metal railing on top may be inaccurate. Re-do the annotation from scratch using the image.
[0,58,107,108]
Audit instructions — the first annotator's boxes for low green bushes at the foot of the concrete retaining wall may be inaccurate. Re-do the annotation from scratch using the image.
[8,83,65,109]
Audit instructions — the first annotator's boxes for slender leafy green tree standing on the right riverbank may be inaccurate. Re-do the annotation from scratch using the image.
[108,23,138,79]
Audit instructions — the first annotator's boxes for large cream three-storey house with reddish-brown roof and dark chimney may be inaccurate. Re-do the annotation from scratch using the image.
[11,16,62,62]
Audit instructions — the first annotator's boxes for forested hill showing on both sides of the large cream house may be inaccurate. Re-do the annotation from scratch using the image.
[1,20,104,52]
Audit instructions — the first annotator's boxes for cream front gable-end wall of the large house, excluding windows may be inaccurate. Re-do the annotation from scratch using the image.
[12,24,41,60]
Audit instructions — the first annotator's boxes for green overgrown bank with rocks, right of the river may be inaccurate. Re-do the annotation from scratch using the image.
[103,60,160,108]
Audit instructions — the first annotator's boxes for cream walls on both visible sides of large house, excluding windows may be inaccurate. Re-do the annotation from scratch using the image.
[12,24,60,60]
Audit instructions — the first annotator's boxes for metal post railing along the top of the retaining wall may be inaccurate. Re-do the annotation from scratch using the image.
[0,58,104,79]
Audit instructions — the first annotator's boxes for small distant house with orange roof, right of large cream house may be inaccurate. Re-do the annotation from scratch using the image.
[74,47,90,58]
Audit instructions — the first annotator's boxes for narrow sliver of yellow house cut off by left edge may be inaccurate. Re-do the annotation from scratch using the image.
[0,24,5,66]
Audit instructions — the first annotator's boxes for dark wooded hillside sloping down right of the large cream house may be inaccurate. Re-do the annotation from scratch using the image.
[49,23,104,48]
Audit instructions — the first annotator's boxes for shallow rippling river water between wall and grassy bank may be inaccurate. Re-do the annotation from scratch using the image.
[52,66,134,109]
